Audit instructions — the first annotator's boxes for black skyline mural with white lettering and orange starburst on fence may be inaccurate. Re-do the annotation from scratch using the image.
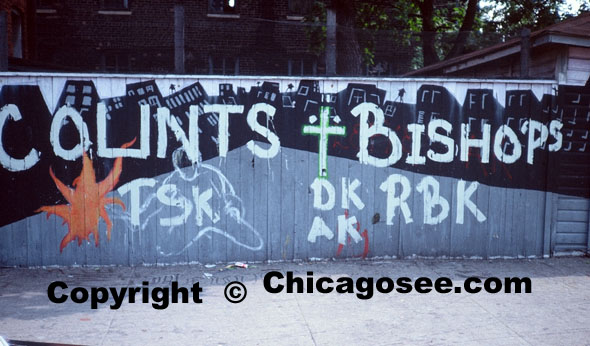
[0,80,590,256]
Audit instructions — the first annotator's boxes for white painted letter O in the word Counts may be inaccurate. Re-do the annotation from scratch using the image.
[49,105,91,161]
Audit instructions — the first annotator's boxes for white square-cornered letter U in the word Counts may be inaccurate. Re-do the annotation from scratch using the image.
[96,102,150,159]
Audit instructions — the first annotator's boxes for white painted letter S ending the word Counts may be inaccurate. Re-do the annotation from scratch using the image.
[246,103,281,159]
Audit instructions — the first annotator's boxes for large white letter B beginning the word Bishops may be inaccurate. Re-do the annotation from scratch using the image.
[350,102,402,167]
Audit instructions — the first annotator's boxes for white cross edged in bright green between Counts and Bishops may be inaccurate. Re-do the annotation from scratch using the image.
[303,107,346,179]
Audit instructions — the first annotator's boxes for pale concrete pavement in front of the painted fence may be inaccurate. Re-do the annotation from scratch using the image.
[0,257,590,345]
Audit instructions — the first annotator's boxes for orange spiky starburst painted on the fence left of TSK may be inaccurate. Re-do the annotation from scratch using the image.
[36,139,135,252]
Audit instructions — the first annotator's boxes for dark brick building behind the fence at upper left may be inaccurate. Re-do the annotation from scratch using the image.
[0,0,408,75]
